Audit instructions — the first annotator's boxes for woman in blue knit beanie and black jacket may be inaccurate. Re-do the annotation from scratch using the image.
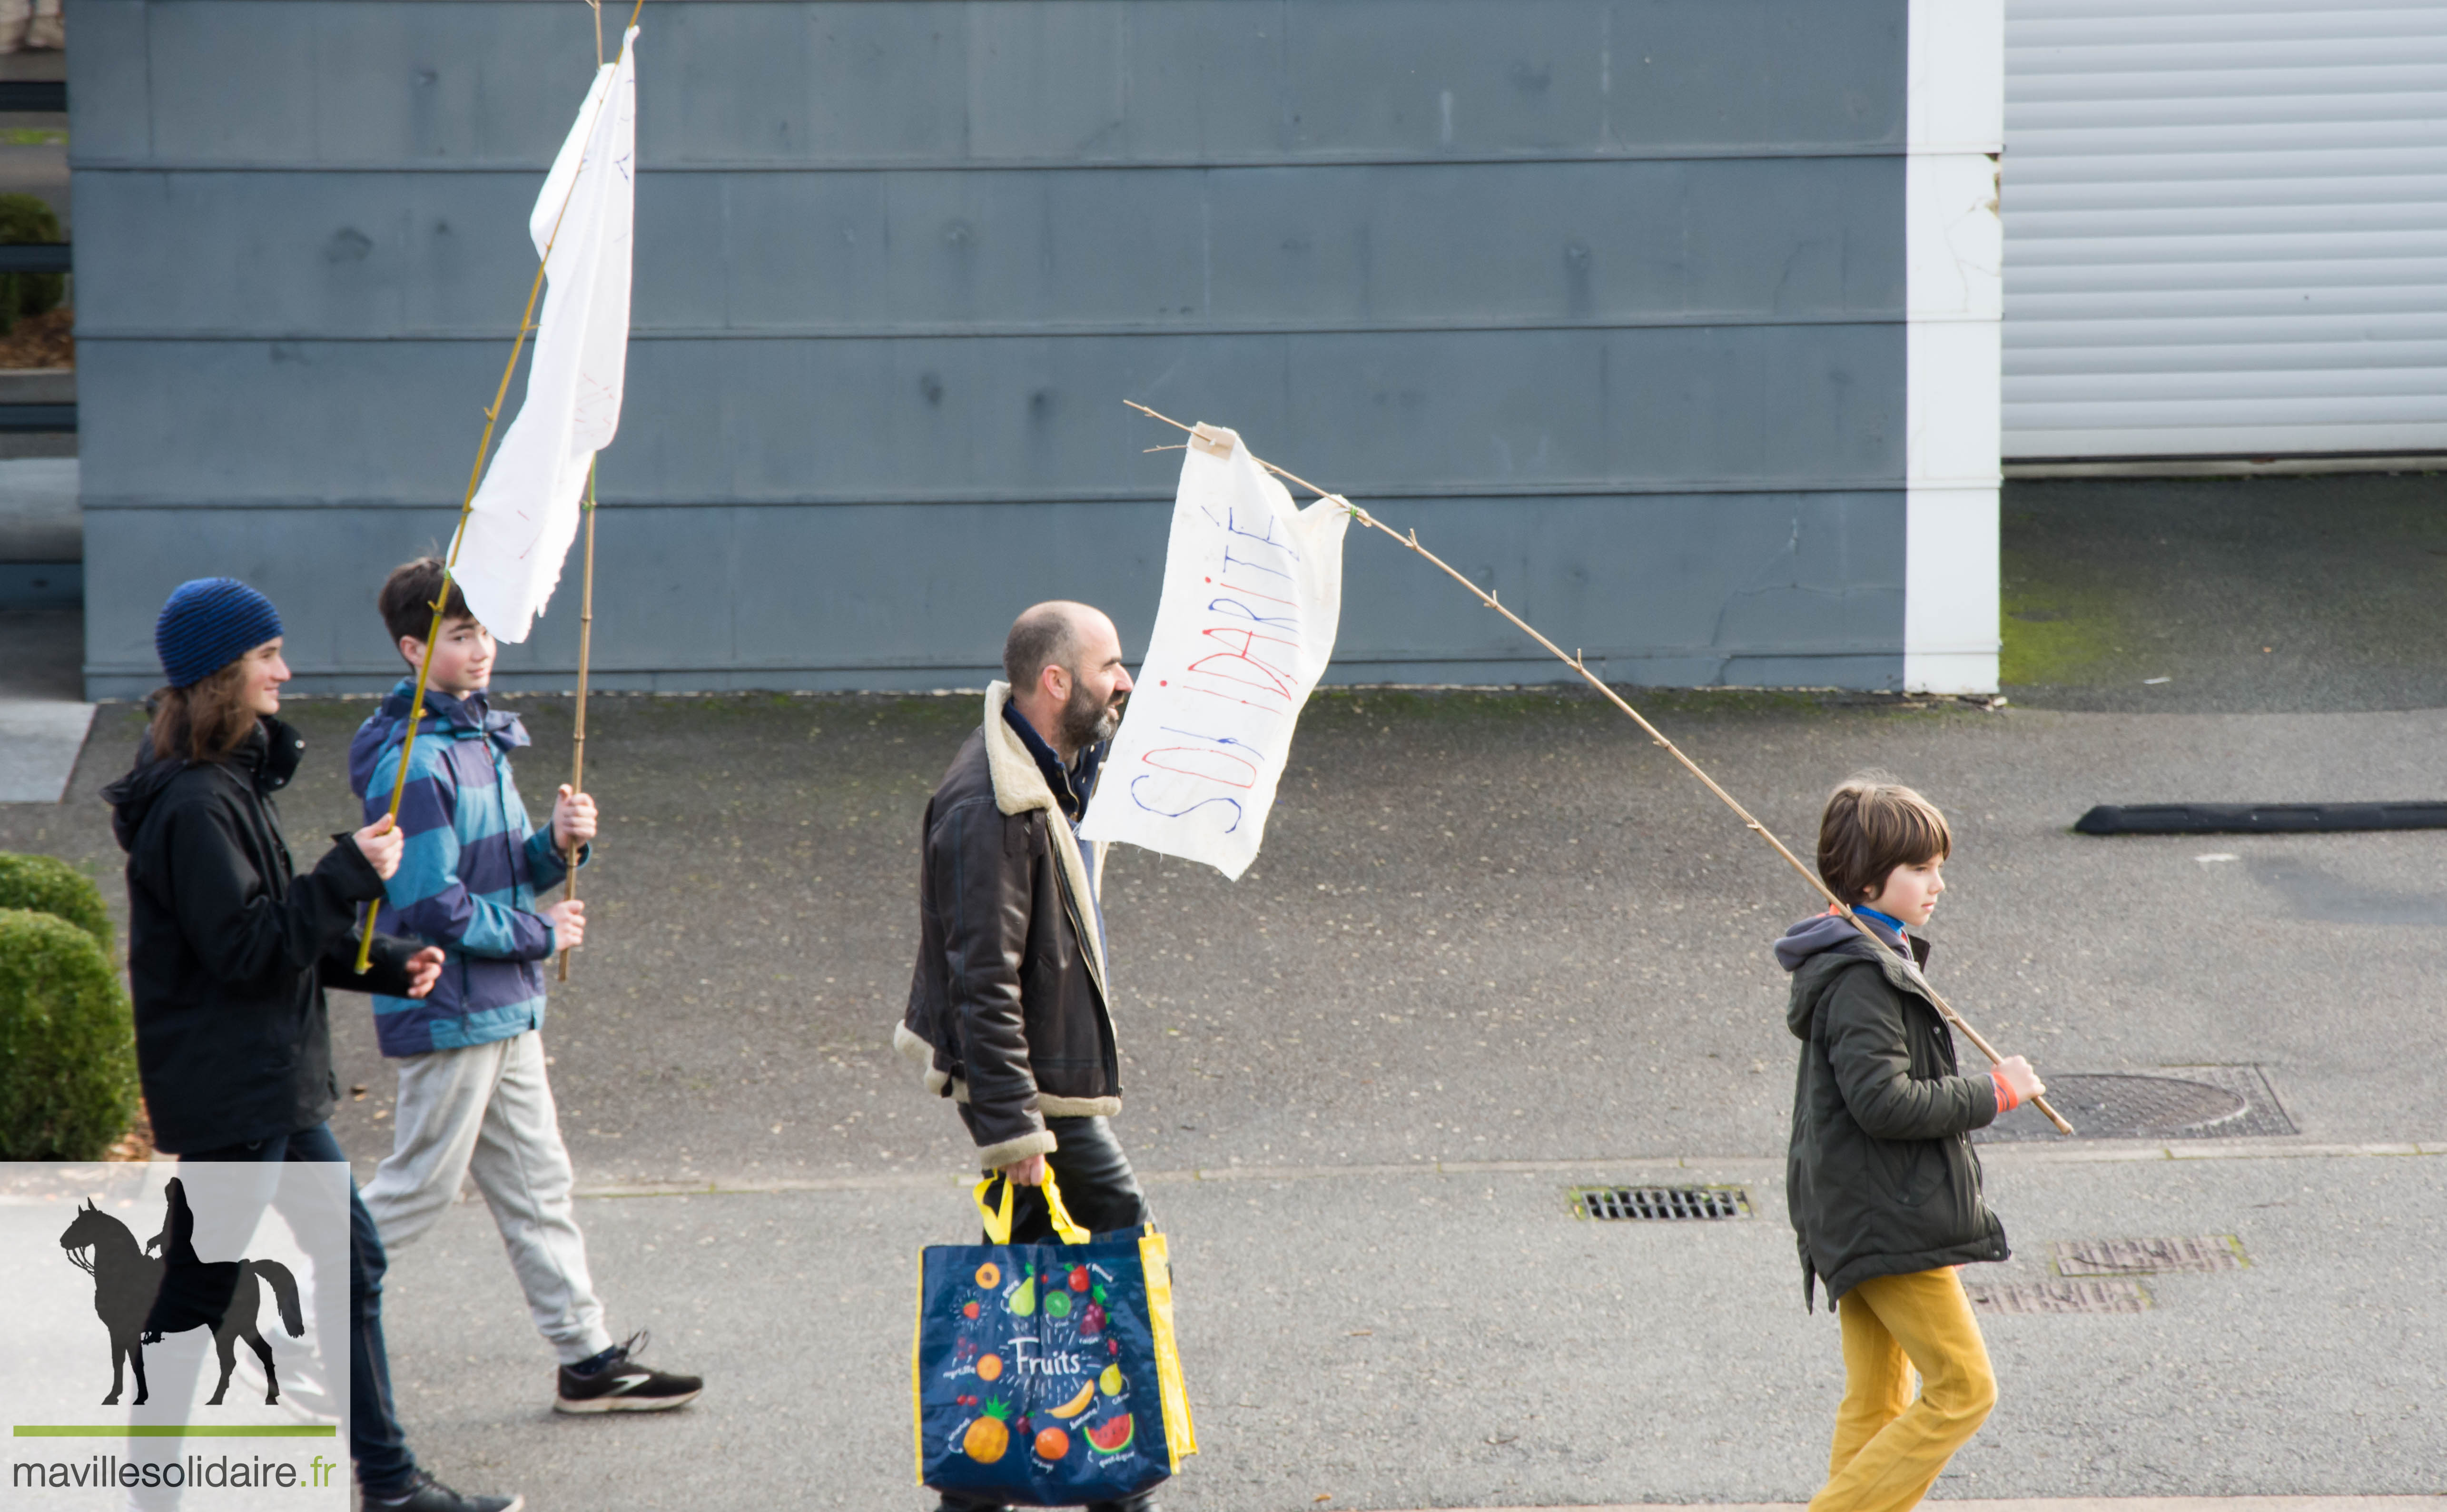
[103,577,516,1512]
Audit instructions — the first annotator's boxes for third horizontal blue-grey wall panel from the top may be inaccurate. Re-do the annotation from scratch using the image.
[79,326,1904,504]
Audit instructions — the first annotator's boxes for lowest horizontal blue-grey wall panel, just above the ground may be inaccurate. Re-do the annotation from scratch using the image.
[86,492,1904,697]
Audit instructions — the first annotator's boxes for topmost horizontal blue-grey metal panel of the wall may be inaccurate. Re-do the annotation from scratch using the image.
[76,0,1906,169]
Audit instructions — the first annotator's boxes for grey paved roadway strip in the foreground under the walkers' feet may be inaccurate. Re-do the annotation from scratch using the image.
[372,1150,2447,1512]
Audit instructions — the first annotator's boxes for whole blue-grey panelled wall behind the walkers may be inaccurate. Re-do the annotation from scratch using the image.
[71,0,1914,695]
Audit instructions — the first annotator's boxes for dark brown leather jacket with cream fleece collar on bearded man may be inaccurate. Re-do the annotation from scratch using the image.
[893,682,1121,1169]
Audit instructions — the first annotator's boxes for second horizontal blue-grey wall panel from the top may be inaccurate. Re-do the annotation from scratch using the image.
[76,157,1904,340]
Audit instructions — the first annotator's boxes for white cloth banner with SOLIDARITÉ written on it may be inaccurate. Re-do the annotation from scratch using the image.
[1079,425,1351,879]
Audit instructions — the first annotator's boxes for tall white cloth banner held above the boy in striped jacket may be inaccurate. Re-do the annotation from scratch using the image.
[450,27,636,641]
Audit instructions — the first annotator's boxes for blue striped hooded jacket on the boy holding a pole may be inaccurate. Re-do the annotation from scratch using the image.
[347,680,585,1055]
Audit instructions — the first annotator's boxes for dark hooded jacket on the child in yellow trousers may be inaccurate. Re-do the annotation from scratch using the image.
[1776,915,2012,1306]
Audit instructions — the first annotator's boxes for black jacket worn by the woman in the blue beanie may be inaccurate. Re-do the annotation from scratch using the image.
[103,719,416,1155]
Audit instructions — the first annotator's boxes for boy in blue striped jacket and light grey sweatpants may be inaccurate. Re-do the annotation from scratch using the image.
[347,558,702,1412]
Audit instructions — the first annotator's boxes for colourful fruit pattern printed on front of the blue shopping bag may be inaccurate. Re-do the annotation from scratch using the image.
[942,1265,1138,1465]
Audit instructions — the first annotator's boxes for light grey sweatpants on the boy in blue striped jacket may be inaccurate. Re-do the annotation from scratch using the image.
[365,1030,612,1365]
